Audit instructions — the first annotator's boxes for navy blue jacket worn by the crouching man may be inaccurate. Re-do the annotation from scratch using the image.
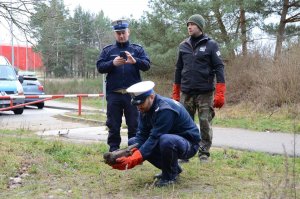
[136,94,201,159]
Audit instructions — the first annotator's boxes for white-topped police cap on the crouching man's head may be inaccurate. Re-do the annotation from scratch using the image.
[126,81,155,105]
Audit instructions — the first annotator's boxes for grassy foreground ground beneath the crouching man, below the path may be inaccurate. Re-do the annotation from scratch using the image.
[0,130,300,199]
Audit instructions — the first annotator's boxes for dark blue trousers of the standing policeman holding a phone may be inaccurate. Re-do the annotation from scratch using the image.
[106,93,139,151]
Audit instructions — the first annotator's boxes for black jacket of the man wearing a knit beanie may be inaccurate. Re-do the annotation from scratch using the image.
[175,35,225,94]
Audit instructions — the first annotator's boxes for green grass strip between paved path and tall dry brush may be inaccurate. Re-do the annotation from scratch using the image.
[213,105,300,134]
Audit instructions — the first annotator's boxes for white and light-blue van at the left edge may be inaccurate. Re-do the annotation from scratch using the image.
[0,56,25,115]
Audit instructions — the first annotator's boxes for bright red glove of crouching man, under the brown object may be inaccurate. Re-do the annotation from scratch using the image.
[112,148,143,170]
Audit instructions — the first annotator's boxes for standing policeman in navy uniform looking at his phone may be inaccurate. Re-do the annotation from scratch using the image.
[97,19,150,152]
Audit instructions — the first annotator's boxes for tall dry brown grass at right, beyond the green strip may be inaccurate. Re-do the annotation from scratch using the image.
[226,43,300,109]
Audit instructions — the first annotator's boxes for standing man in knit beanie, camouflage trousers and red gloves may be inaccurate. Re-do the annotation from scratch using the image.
[172,14,226,161]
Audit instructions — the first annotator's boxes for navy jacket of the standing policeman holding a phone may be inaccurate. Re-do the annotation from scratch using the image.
[96,41,150,93]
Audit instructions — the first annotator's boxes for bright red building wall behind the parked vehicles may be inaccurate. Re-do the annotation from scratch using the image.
[0,45,43,70]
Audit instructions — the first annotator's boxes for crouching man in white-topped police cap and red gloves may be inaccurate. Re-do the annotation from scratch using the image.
[112,81,201,187]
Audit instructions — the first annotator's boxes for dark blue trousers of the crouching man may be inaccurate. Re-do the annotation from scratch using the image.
[128,134,199,180]
